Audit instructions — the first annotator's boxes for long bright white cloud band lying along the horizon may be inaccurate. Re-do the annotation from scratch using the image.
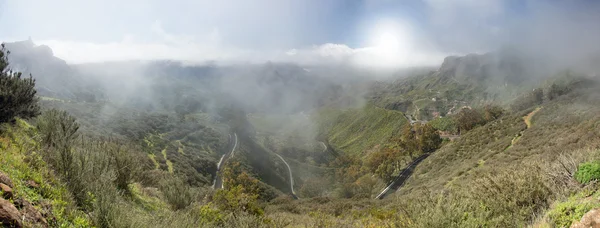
[30,21,445,68]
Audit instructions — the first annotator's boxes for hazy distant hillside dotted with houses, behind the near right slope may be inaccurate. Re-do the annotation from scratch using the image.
[367,50,546,120]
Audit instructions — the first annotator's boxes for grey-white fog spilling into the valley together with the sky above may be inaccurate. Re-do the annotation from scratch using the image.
[0,0,600,162]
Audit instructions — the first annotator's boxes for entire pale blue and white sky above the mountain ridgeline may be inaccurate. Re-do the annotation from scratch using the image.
[0,0,600,67]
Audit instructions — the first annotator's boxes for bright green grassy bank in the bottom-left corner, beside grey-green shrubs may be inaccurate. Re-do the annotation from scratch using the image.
[0,120,91,227]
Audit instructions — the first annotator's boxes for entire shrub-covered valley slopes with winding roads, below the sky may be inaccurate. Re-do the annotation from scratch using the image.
[0,42,600,227]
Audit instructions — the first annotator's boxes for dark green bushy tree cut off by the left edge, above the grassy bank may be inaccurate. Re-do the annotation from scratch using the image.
[0,44,40,123]
